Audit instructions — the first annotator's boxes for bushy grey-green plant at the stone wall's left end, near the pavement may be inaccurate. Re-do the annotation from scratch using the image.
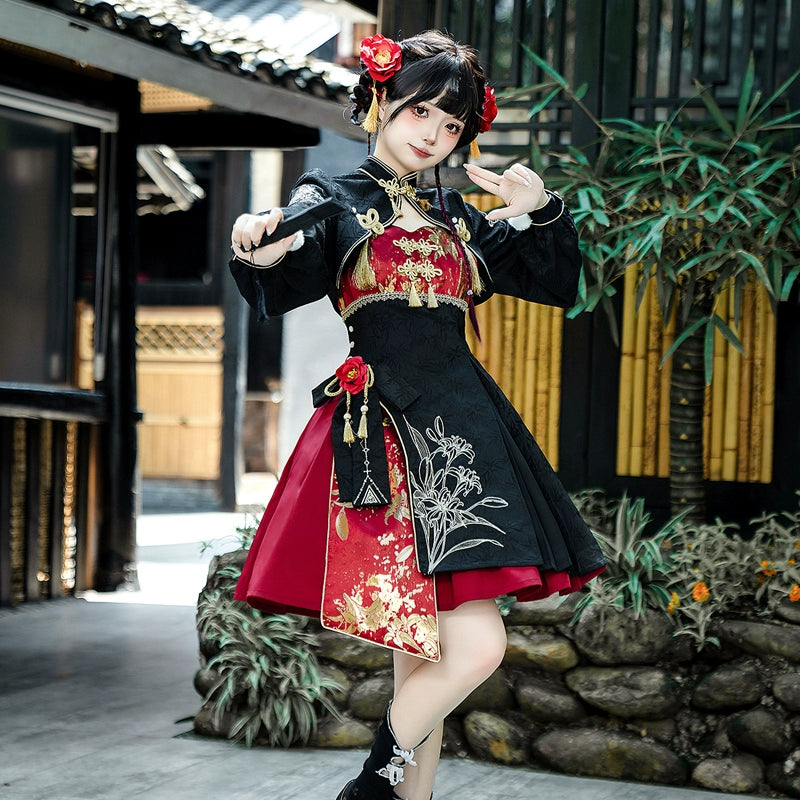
[197,564,340,747]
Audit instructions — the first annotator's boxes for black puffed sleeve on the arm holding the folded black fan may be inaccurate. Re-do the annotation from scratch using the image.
[229,170,335,320]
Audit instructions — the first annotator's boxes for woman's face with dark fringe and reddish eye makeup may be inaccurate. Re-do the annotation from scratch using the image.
[375,100,464,175]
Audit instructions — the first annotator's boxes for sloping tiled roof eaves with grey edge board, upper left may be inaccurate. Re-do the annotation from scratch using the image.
[0,0,356,136]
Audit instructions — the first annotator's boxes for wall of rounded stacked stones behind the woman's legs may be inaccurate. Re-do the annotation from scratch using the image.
[306,601,800,797]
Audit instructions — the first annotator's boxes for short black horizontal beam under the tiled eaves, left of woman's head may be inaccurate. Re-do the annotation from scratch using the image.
[136,111,319,150]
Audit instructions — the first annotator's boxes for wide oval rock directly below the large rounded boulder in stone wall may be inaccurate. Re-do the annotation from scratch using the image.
[566,667,680,719]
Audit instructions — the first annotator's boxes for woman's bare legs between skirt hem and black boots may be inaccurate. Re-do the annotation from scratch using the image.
[391,600,506,800]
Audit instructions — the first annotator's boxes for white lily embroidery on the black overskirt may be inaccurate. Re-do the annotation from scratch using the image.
[403,417,508,570]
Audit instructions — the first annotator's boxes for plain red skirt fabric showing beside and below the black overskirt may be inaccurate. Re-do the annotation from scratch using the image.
[234,403,602,617]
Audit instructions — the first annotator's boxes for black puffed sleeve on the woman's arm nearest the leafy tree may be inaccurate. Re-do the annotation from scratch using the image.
[464,193,581,308]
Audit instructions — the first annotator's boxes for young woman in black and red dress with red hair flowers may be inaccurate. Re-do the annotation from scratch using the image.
[231,31,603,800]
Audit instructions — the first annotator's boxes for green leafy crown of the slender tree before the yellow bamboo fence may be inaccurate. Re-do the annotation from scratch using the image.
[501,51,800,382]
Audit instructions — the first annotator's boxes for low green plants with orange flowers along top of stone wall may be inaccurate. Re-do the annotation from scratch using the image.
[573,490,800,650]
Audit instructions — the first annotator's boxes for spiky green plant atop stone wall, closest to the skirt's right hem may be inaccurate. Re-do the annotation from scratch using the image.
[574,495,685,621]
